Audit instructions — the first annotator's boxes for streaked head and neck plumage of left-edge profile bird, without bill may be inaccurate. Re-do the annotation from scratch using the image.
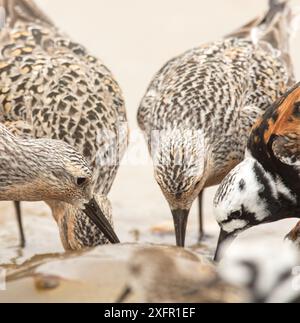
[0,124,92,200]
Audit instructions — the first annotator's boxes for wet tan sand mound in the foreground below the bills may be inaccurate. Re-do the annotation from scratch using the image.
[0,244,206,303]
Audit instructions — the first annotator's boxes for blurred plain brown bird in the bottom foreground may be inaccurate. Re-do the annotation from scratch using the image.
[118,248,245,303]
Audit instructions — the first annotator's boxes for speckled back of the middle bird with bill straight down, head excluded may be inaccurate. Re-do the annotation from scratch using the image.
[138,0,293,184]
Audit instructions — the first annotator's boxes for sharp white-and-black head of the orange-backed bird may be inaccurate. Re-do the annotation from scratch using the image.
[214,156,278,258]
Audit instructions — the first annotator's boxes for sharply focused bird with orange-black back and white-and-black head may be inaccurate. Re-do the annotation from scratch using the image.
[214,83,300,258]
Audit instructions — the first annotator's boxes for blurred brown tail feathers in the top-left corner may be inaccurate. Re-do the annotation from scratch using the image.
[0,0,53,26]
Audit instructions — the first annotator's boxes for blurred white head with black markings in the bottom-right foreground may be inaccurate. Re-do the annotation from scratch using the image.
[218,236,300,303]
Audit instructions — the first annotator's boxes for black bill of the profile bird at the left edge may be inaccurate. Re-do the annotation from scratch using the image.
[84,198,120,244]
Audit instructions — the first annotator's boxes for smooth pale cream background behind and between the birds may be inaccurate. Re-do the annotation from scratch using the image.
[0,0,300,263]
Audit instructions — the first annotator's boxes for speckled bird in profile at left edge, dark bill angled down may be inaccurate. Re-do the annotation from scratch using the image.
[0,124,119,247]
